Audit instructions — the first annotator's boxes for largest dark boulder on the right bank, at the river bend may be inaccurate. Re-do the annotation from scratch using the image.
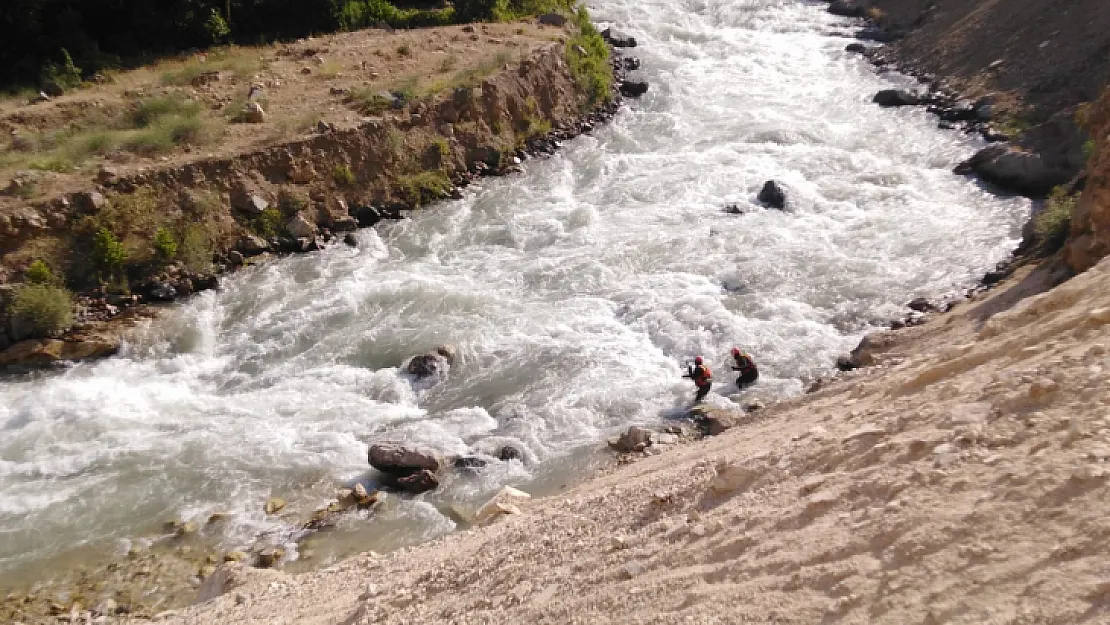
[955,143,1071,198]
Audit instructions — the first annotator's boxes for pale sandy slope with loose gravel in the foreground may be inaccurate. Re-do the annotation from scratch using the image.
[154,256,1110,625]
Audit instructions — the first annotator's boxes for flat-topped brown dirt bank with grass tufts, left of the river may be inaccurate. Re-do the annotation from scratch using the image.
[0,14,615,366]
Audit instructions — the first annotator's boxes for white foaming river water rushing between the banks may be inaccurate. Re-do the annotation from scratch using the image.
[0,0,1028,571]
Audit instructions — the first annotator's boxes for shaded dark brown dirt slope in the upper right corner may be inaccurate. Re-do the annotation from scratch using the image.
[866,0,1110,172]
